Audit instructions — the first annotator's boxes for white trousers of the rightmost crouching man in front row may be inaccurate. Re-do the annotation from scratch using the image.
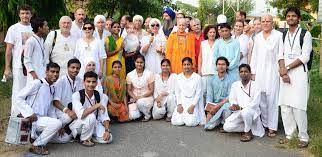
[223,108,265,137]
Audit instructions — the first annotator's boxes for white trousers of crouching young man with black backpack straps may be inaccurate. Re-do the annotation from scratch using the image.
[69,113,96,141]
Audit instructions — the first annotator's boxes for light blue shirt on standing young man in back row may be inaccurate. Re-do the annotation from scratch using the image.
[214,38,240,81]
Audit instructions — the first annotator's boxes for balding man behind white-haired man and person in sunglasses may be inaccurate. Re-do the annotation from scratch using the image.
[71,8,86,39]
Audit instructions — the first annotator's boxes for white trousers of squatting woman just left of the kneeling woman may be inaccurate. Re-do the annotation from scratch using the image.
[152,95,176,119]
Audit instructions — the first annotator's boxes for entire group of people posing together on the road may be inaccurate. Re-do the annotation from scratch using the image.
[4,5,312,155]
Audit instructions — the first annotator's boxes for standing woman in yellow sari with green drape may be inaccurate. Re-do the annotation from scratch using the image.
[105,22,125,79]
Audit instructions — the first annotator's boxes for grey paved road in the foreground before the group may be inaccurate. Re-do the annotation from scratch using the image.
[21,121,304,157]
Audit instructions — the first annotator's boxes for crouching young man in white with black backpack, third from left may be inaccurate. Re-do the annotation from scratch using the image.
[70,72,113,146]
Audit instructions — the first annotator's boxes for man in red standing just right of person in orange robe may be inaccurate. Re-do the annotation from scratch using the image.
[190,19,205,65]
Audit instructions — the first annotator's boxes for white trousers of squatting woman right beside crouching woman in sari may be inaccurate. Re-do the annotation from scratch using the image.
[129,97,153,120]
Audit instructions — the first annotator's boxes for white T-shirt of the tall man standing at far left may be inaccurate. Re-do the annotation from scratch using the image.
[4,22,33,68]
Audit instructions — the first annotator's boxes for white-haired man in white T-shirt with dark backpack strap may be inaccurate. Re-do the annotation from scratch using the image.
[45,16,77,76]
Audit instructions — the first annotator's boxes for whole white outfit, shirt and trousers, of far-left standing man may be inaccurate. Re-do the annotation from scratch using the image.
[4,23,32,116]
